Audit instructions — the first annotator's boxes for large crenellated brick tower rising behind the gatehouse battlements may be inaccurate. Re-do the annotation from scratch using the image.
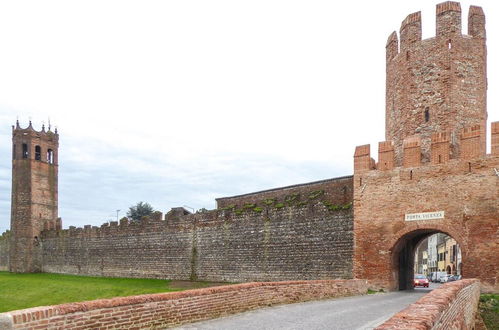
[385,1,487,166]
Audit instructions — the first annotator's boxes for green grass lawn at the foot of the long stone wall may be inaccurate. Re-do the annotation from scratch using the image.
[0,272,223,313]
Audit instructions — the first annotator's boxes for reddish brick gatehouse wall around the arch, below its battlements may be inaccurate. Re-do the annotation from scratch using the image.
[354,156,499,291]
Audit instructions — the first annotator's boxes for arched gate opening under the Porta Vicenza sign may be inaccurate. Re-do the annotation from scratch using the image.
[392,229,463,290]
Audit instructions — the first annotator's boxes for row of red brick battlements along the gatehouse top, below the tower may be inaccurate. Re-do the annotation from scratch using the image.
[354,121,499,173]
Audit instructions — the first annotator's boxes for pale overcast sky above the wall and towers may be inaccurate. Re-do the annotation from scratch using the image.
[0,0,499,233]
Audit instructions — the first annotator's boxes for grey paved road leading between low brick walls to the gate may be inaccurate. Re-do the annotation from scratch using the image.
[177,284,438,330]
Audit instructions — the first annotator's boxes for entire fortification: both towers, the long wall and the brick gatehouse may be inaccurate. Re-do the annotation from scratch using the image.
[0,2,499,310]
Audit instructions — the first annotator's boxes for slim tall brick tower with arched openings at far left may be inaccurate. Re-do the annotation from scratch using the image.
[9,122,60,273]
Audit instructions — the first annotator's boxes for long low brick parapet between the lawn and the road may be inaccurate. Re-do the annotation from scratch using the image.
[0,280,368,329]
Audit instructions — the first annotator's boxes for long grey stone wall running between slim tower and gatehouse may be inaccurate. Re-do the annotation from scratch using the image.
[36,177,353,282]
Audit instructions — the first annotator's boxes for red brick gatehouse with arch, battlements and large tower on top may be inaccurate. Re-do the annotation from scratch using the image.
[354,2,499,291]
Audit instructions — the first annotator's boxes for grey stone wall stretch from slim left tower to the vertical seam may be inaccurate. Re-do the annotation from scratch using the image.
[42,219,193,279]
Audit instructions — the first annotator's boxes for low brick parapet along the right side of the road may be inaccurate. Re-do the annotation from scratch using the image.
[376,279,480,330]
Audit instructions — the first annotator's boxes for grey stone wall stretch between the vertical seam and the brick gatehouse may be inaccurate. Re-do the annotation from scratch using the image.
[194,204,353,282]
